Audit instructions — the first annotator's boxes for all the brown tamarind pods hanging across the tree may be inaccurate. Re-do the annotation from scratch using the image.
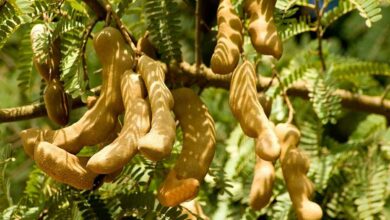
[20,0,322,219]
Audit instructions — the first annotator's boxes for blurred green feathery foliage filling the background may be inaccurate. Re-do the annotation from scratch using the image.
[0,0,390,219]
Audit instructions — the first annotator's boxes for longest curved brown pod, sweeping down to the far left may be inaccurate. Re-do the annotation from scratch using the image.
[20,27,133,155]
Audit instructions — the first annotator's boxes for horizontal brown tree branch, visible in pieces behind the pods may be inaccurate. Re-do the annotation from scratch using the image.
[0,62,390,124]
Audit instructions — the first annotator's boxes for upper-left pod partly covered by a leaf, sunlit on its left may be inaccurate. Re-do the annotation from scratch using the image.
[30,24,61,82]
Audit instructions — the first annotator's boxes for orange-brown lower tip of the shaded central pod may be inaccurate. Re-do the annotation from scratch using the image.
[157,170,200,207]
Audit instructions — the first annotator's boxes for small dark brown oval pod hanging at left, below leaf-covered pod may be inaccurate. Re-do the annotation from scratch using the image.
[43,79,69,126]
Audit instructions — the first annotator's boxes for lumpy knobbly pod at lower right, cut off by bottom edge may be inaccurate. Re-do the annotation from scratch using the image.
[275,124,322,220]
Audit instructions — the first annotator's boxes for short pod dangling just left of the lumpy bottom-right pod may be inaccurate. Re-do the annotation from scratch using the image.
[249,156,275,210]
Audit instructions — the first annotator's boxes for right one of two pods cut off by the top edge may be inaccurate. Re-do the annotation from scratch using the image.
[244,0,283,59]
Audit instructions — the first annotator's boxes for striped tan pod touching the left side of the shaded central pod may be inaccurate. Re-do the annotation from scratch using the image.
[137,55,176,161]
